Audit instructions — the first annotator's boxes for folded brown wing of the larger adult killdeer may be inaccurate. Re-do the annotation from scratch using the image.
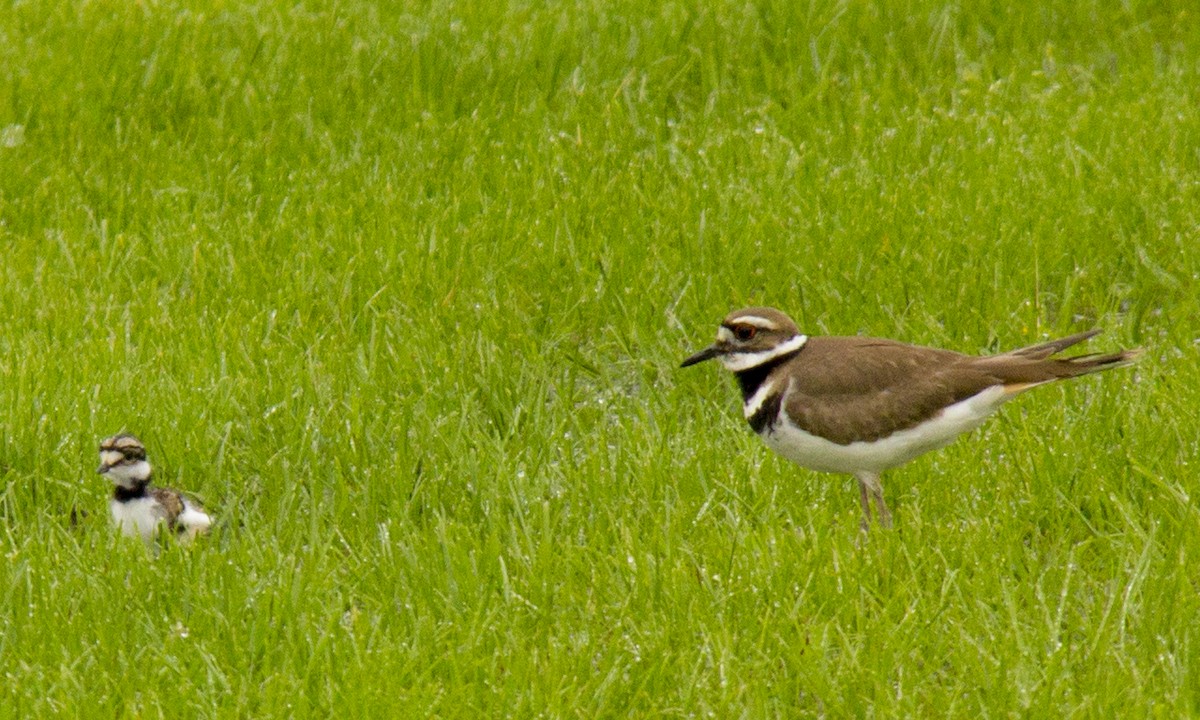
[786,337,1003,445]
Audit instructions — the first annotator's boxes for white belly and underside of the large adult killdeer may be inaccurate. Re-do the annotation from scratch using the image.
[751,385,1012,474]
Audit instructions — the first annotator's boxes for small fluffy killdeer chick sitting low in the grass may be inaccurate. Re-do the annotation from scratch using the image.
[96,434,212,542]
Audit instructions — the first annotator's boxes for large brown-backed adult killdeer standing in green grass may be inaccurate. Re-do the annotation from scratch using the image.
[682,307,1141,530]
